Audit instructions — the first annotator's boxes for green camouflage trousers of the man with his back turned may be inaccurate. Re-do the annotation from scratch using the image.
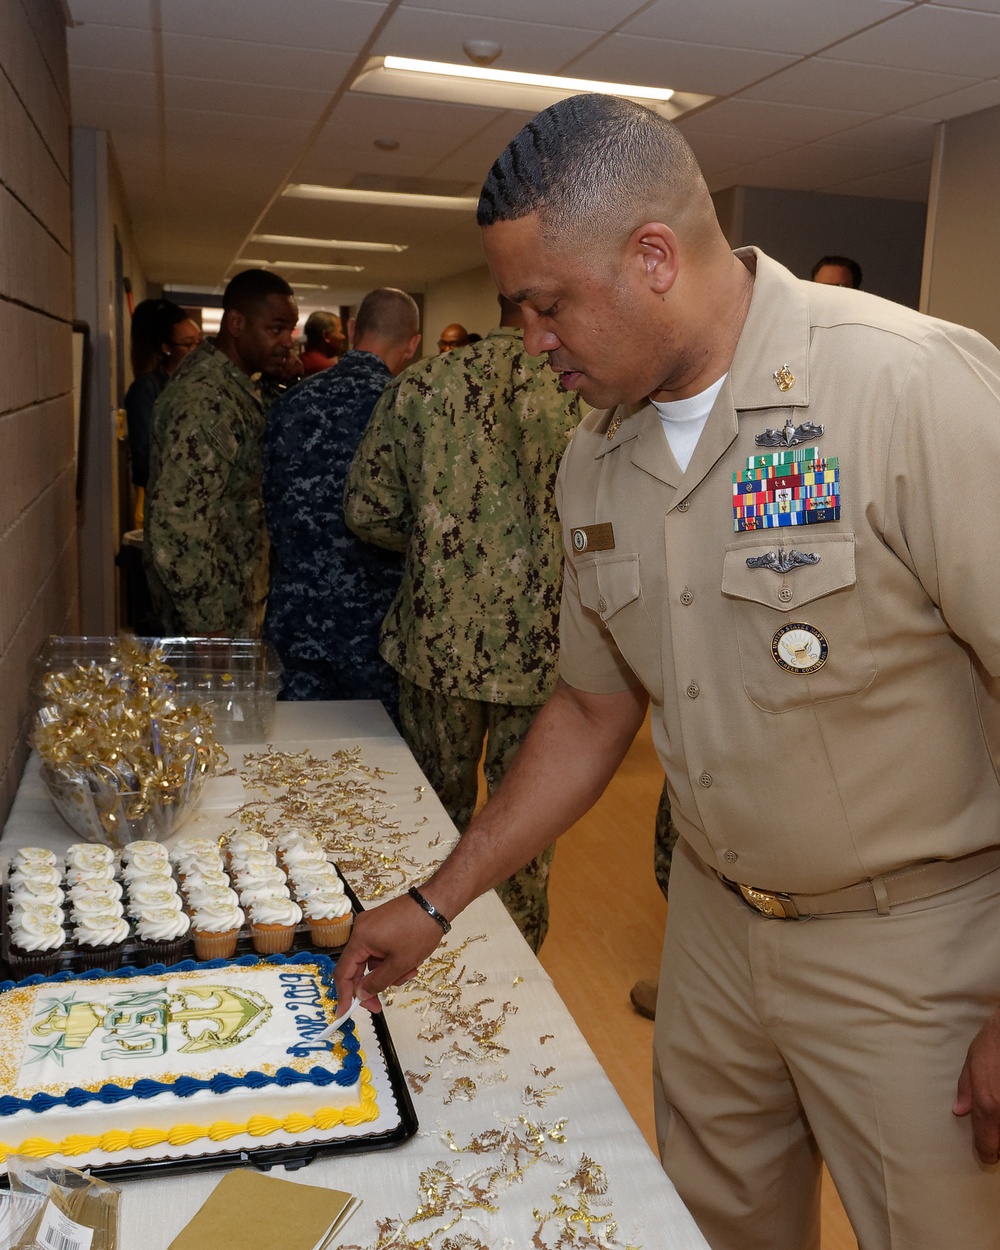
[399,676,555,954]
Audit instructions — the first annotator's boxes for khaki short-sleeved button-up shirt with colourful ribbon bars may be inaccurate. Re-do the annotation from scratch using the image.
[559,249,1000,893]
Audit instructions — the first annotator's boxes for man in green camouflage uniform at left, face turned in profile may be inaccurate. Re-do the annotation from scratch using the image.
[144,269,298,638]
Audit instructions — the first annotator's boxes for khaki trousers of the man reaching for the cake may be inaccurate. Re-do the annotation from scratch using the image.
[654,839,1000,1250]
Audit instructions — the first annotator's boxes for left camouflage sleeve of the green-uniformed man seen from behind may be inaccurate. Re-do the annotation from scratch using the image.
[344,385,414,551]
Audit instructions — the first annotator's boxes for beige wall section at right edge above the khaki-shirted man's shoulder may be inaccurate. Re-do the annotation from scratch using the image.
[920,109,1000,346]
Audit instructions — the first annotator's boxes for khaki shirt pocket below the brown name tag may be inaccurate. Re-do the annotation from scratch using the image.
[575,554,664,701]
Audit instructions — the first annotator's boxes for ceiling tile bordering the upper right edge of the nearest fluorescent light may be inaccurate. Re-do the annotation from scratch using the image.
[568,35,795,95]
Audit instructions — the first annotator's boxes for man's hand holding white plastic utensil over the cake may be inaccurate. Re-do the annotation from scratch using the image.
[334,894,444,1011]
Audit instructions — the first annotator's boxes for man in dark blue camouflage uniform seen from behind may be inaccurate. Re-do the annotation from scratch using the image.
[264,288,420,720]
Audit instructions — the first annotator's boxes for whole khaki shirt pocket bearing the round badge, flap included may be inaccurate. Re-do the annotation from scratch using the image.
[723,531,876,711]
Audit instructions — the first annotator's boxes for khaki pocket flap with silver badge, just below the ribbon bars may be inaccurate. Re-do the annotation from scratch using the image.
[723,534,856,613]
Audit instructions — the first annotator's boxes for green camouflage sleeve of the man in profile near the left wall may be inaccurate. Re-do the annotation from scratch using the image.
[146,400,236,634]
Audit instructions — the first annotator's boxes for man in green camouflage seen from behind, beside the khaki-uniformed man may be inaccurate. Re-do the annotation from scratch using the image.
[345,297,580,950]
